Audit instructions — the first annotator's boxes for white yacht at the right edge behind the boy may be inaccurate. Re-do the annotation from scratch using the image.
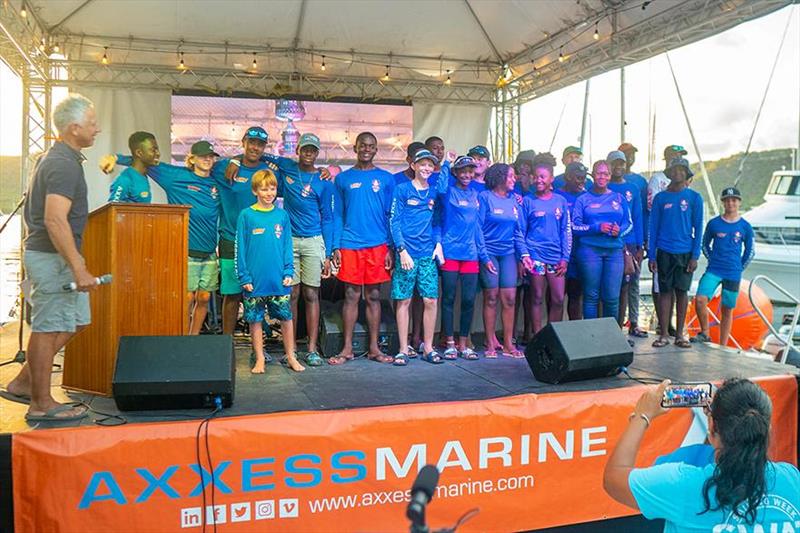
[743,170,800,302]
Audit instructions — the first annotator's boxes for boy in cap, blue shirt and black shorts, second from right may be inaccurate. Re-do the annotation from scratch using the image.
[647,157,703,348]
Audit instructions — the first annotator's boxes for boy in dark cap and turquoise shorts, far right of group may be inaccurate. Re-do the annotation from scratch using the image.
[691,187,754,346]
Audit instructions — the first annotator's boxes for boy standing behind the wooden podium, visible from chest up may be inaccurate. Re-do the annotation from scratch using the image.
[108,131,161,204]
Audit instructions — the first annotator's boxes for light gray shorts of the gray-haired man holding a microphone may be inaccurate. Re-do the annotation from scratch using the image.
[23,250,92,333]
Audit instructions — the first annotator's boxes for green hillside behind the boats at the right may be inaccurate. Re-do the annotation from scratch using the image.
[692,148,792,209]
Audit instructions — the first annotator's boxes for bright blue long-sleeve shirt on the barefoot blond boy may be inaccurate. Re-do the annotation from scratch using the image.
[234,204,294,296]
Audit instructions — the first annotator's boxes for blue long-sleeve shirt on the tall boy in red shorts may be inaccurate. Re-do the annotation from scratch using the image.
[333,168,394,250]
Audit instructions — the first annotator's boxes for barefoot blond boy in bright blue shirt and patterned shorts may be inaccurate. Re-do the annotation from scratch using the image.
[235,170,305,374]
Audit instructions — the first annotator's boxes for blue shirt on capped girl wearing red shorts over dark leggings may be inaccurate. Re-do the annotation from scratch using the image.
[439,180,489,263]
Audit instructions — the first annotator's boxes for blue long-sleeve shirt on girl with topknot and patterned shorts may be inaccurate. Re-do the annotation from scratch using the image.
[522,194,572,265]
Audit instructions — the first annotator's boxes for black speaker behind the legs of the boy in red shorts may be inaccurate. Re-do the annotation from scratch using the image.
[319,299,399,357]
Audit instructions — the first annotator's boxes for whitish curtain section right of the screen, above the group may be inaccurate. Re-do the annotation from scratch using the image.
[414,102,492,155]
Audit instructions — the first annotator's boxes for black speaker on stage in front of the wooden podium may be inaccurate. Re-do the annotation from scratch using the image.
[111,335,236,411]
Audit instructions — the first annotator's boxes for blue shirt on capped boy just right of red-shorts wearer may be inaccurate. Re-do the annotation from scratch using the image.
[389,181,441,259]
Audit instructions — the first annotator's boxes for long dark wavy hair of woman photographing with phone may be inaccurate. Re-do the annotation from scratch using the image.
[701,378,772,524]
